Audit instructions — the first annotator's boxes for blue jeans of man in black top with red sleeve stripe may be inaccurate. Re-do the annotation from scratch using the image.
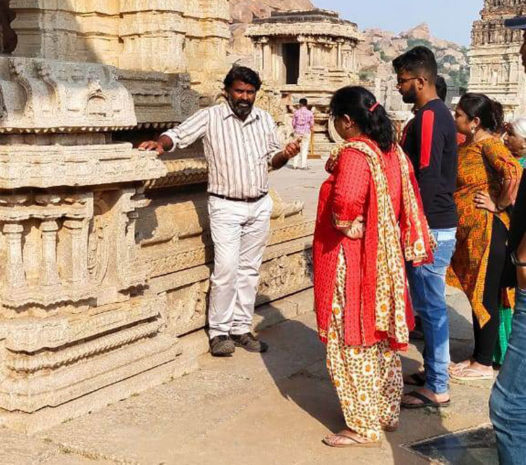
[407,228,457,394]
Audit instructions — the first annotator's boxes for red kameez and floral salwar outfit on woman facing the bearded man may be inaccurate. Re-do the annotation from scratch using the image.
[313,137,432,441]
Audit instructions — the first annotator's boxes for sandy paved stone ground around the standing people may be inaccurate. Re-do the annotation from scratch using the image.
[0,161,500,465]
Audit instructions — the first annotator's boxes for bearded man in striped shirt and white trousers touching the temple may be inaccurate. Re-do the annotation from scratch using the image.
[139,66,300,356]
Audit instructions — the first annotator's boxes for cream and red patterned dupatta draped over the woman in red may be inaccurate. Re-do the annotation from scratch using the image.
[315,139,433,349]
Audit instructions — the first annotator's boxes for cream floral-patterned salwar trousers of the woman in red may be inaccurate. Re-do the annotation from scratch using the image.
[327,249,404,441]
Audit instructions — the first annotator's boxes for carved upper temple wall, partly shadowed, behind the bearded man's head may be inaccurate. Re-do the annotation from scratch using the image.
[8,0,230,92]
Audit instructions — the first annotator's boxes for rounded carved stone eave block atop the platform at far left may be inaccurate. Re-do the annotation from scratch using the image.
[0,57,137,132]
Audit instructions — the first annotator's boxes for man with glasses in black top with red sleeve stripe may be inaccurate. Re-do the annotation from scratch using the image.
[393,47,457,408]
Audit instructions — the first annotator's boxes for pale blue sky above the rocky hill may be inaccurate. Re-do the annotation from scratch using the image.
[312,0,484,46]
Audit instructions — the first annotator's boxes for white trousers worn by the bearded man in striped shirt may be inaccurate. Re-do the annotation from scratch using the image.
[208,195,272,339]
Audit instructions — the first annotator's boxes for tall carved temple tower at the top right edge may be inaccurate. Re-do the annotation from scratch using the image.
[469,0,526,119]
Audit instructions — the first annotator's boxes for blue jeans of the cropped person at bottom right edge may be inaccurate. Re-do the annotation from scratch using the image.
[489,289,526,465]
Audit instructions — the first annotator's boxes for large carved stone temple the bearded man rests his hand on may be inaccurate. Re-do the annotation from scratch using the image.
[0,0,313,431]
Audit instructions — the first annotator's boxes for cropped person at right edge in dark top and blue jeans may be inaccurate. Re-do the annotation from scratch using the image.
[489,16,526,465]
